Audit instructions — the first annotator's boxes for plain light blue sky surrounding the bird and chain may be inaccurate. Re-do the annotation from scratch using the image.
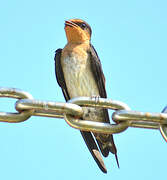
[0,0,167,180]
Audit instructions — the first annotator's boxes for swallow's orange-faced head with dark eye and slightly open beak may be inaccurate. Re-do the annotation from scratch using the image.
[65,19,92,43]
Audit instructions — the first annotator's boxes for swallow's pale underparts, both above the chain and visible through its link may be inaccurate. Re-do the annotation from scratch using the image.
[62,57,104,122]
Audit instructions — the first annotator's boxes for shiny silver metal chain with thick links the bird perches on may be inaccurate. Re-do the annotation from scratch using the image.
[0,88,167,141]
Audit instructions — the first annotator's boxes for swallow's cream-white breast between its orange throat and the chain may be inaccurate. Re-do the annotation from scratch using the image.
[62,56,99,98]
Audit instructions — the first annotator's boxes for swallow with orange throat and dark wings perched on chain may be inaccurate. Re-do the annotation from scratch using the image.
[54,19,119,173]
